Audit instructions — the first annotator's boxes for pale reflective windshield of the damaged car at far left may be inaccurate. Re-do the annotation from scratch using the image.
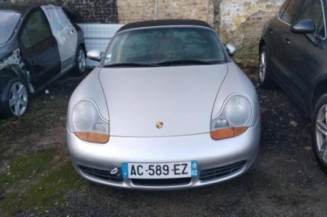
[0,11,20,44]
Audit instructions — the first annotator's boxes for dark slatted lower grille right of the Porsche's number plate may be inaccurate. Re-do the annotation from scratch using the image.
[200,161,246,181]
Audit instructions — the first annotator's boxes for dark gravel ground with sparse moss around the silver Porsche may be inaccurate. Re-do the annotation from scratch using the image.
[0,68,327,217]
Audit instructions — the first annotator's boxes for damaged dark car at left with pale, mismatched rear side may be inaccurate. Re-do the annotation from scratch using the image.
[0,4,86,118]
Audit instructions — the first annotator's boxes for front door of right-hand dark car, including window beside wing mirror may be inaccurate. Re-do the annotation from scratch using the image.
[288,0,326,109]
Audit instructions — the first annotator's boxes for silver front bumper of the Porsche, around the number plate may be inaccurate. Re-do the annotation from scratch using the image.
[67,121,260,190]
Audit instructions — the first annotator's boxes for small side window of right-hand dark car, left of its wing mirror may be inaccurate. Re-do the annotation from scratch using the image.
[280,0,304,24]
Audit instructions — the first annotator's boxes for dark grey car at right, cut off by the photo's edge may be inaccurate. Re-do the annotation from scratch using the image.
[259,0,327,172]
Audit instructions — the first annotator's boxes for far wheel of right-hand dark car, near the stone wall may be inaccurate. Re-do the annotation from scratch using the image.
[258,46,276,89]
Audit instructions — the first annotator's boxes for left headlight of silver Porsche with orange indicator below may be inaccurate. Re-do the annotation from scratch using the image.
[72,101,109,143]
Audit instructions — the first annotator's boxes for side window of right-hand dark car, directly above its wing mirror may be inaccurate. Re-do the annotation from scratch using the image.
[300,0,326,38]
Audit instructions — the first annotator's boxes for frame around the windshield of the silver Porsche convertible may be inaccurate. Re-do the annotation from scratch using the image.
[99,25,232,68]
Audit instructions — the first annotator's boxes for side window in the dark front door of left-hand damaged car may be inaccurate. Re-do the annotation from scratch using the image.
[20,10,51,48]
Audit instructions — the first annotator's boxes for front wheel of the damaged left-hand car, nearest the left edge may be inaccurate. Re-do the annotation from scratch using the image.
[0,77,29,118]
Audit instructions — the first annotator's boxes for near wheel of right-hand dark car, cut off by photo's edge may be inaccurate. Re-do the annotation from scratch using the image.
[311,93,327,174]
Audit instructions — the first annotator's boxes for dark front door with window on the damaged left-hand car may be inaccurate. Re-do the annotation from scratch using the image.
[18,8,60,88]
